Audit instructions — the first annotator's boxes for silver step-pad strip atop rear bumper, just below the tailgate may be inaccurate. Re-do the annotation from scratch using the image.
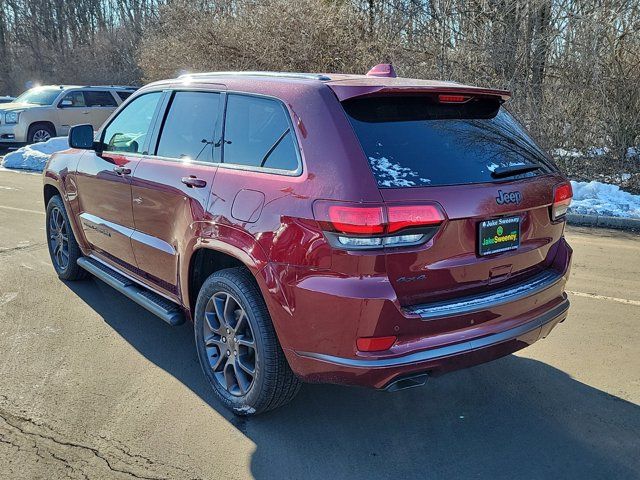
[403,270,562,320]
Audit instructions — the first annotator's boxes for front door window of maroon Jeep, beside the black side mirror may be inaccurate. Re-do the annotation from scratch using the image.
[102,92,162,153]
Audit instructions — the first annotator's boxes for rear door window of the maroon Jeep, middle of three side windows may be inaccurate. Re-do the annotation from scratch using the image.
[156,92,220,162]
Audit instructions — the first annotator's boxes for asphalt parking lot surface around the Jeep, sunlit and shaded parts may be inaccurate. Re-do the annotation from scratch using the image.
[0,171,640,480]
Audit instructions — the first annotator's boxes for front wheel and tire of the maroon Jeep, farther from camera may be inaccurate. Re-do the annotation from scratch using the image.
[46,195,88,280]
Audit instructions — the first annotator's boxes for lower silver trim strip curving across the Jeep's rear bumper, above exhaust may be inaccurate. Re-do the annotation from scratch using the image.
[296,297,569,368]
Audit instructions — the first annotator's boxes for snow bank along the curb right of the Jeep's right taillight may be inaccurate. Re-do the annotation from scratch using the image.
[569,181,640,218]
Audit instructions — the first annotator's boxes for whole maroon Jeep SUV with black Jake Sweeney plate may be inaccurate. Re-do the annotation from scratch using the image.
[44,65,572,415]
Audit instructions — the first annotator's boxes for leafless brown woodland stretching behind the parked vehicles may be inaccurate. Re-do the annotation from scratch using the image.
[0,0,640,190]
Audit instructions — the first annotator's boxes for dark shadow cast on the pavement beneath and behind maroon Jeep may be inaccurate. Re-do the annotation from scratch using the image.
[68,280,640,480]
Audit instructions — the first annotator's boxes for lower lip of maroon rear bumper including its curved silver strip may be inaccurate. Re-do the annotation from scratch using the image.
[289,294,569,388]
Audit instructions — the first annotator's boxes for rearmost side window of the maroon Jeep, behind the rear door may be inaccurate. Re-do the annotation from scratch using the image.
[223,95,298,171]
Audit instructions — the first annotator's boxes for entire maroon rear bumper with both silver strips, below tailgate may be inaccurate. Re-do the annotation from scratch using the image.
[272,239,572,388]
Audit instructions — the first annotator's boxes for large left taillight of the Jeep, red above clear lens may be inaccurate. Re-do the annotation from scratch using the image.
[313,200,445,250]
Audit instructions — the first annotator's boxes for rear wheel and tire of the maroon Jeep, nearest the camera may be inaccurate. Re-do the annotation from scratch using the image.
[194,267,301,416]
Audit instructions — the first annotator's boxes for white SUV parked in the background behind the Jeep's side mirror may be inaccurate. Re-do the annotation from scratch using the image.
[0,85,136,145]
